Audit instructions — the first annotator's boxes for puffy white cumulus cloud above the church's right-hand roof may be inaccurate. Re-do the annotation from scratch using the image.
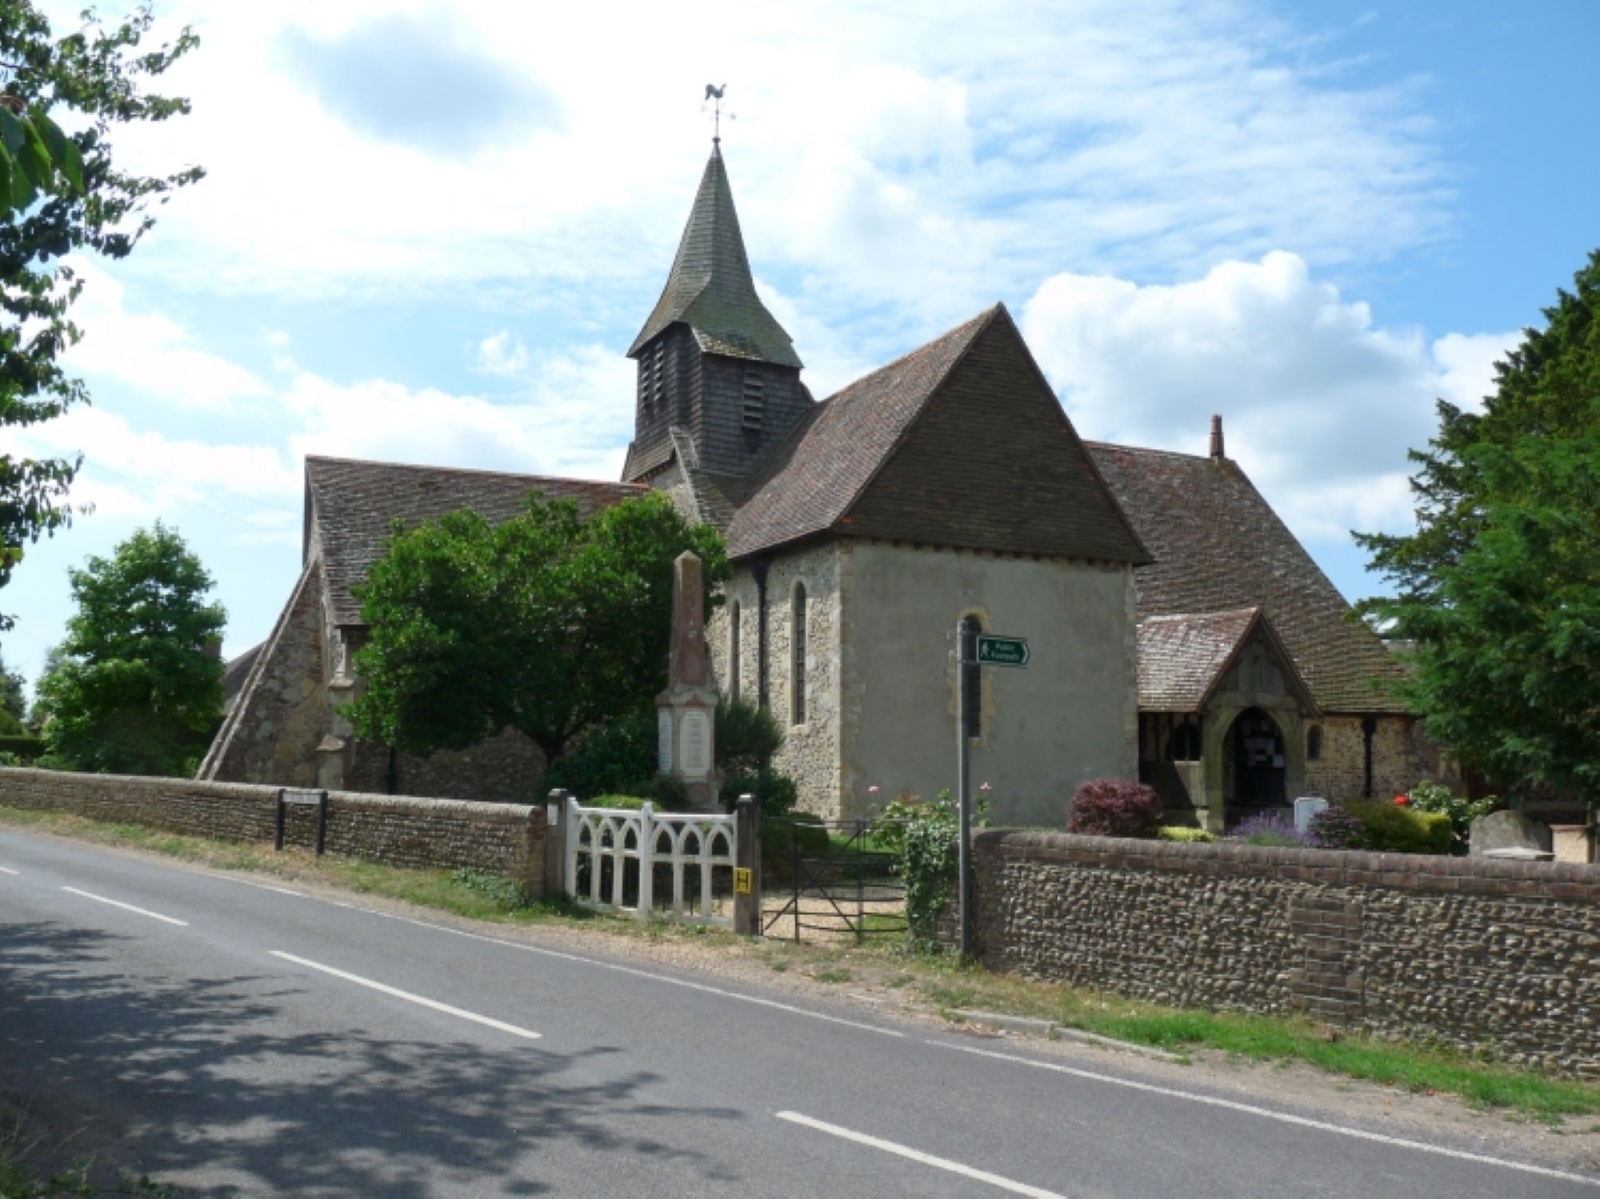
[1022,251,1515,539]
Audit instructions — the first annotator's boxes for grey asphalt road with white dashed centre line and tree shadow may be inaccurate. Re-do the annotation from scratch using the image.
[0,831,1600,1199]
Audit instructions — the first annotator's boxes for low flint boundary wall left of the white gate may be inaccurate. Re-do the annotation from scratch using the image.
[0,767,544,887]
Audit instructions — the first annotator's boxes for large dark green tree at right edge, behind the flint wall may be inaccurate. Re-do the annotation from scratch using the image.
[1357,251,1600,799]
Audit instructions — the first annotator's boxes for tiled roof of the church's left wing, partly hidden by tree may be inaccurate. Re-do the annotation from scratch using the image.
[306,458,650,624]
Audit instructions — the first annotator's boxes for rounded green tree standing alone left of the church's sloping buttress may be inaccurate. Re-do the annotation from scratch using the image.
[38,522,227,775]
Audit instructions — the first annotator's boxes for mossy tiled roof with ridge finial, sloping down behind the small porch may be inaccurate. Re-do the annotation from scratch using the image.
[1086,442,1406,714]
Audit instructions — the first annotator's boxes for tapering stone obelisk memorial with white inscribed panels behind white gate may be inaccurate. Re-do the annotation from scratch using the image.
[656,551,717,812]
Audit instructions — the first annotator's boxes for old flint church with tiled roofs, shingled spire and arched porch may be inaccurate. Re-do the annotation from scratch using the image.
[202,147,1429,828]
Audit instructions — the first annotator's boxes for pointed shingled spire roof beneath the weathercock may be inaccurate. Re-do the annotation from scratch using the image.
[627,146,802,370]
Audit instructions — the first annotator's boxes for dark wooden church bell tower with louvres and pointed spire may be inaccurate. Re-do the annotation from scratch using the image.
[624,147,813,482]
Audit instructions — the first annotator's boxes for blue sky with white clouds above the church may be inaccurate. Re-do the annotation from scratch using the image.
[0,0,1600,682]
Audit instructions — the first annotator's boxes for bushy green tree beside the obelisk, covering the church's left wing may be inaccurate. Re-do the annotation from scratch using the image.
[354,493,730,762]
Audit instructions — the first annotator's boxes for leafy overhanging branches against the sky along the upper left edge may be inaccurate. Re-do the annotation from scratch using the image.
[0,0,203,629]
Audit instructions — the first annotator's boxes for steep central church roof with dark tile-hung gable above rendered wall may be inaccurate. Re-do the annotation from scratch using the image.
[728,306,1149,562]
